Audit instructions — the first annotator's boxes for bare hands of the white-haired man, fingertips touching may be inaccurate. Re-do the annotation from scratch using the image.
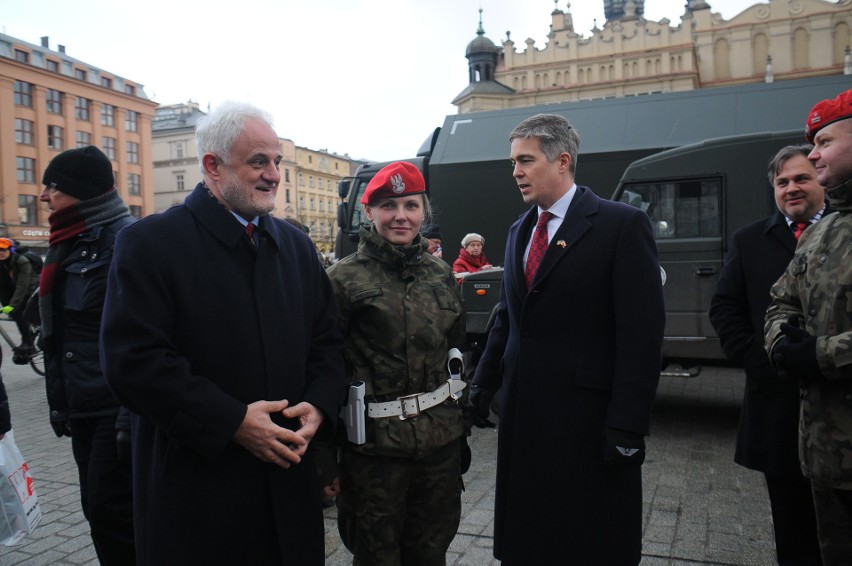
[234,399,323,468]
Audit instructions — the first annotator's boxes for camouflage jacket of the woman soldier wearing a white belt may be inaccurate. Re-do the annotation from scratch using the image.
[328,227,469,457]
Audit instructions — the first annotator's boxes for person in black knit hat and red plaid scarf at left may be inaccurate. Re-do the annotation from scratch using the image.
[39,146,135,566]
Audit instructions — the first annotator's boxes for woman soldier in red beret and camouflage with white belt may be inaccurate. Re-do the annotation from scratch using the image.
[325,162,470,566]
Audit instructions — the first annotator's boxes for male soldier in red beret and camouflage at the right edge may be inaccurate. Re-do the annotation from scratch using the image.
[765,90,852,566]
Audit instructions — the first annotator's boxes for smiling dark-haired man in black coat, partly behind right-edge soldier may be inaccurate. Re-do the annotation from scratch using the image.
[710,145,826,566]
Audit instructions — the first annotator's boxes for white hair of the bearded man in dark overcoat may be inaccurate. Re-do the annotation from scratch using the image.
[195,100,272,173]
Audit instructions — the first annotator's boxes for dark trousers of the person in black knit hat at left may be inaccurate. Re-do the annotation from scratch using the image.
[70,415,136,566]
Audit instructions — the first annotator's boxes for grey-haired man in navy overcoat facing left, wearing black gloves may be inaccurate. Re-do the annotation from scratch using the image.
[471,114,665,566]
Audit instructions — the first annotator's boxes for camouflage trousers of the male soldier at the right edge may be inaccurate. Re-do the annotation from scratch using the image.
[811,479,852,566]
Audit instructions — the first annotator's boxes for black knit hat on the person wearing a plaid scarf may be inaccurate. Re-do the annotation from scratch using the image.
[41,145,115,200]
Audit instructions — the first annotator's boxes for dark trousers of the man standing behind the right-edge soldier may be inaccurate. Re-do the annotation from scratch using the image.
[764,475,822,566]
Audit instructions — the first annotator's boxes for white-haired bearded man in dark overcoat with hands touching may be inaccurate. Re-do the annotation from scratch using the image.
[96,103,345,566]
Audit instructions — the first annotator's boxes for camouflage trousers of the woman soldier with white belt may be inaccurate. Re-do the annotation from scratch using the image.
[337,439,462,566]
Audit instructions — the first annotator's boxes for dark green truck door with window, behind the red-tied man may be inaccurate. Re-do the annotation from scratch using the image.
[619,177,724,359]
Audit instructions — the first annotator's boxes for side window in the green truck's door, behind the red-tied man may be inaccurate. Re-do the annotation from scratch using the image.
[619,179,722,240]
